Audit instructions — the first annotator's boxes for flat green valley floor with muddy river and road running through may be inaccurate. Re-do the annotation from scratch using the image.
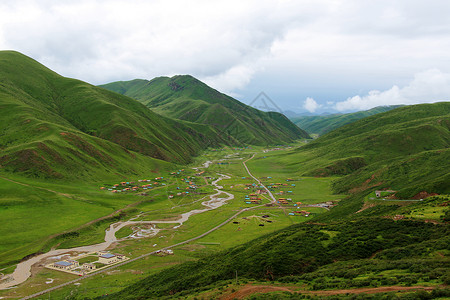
[0,144,340,298]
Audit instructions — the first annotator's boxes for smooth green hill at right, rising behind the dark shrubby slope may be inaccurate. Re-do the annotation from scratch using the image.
[288,102,450,198]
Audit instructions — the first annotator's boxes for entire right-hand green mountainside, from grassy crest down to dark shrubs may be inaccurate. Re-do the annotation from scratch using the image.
[93,103,450,298]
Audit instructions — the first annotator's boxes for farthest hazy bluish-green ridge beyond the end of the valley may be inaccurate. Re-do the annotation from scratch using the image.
[291,105,401,135]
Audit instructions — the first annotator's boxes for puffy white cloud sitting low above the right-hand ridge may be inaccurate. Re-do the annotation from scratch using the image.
[335,69,450,111]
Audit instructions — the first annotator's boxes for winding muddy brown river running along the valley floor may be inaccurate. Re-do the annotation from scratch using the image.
[0,174,234,290]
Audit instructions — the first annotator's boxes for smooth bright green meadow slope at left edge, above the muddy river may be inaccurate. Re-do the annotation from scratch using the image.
[0,178,138,267]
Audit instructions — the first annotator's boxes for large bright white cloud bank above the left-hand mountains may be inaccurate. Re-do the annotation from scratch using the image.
[0,0,308,91]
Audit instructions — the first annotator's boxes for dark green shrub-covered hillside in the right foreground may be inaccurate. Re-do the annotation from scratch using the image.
[109,218,449,299]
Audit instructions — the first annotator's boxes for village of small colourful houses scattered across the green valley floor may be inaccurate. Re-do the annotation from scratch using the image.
[0,148,339,298]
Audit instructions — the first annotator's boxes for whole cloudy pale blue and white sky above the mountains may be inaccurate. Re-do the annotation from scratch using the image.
[0,0,450,113]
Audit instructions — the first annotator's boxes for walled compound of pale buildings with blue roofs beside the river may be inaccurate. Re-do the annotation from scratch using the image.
[45,251,129,275]
